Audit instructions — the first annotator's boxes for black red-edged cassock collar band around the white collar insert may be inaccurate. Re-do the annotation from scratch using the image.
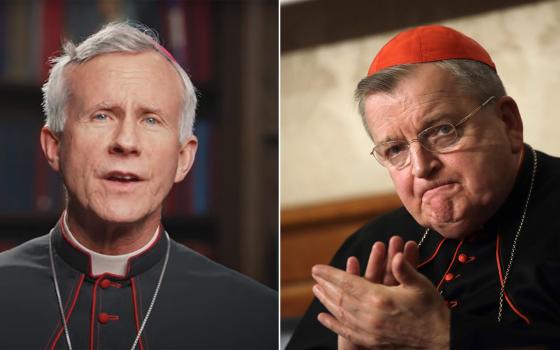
[52,217,166,280]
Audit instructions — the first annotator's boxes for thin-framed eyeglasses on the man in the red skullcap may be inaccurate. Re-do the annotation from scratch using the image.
[371,96,496,170]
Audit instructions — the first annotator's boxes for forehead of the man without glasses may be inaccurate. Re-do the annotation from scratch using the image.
[66,51,184,108]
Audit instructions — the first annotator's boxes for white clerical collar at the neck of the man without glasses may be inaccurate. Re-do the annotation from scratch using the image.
[62,212,159,276]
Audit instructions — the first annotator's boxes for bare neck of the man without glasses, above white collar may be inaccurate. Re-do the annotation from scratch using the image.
[65,207,161,255]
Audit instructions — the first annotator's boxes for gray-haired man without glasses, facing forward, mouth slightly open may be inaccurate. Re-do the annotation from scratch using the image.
[0,23,277,349]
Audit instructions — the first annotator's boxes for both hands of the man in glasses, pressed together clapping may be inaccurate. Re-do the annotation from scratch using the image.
[312,236,450,350]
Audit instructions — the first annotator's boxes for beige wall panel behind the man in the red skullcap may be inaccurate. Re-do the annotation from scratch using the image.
[280,1,560,208]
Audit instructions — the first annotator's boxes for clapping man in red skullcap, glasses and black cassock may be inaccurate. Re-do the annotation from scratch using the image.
[288,25,560,349]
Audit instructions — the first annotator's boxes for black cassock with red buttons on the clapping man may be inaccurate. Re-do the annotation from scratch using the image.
[288,146,560,350]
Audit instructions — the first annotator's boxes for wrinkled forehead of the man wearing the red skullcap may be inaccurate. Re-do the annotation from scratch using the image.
[364,63,471,143]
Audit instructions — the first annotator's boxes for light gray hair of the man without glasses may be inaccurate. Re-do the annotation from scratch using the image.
[43,22,197,142]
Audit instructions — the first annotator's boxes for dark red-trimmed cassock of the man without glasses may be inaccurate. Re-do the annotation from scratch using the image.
[0,222,278,350]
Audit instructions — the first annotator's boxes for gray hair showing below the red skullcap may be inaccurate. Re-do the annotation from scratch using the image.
[354,59,506,137]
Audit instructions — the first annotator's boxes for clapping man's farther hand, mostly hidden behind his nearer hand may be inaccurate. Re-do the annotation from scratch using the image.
[338,236,418,350]
